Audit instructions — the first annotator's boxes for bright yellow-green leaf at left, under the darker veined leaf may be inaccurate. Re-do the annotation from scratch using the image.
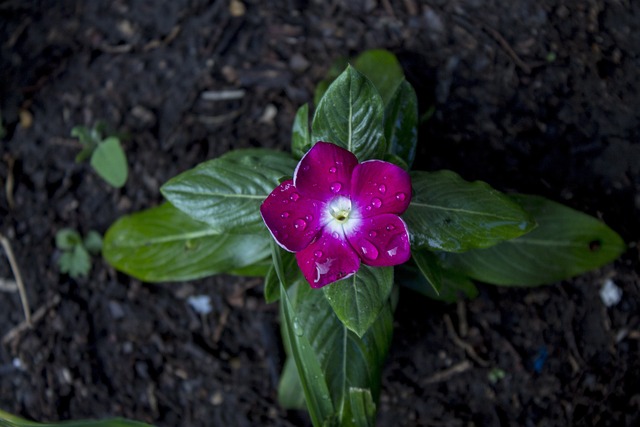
[103,203,270,282]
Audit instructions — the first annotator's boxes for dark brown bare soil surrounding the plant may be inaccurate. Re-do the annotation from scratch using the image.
[0,0,640,426]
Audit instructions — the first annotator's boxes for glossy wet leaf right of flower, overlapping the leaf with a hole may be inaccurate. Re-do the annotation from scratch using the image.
[403,171,535,252]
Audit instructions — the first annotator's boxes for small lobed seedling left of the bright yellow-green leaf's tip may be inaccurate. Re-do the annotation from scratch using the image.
[56,228,102,279]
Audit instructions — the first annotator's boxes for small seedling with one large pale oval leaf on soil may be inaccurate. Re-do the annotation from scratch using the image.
[71,122,128,188]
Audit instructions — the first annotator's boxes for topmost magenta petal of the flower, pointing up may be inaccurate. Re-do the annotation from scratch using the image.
[293,141,358,201]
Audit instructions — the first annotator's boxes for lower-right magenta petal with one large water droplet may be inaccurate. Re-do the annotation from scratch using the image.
[347,214,411,267]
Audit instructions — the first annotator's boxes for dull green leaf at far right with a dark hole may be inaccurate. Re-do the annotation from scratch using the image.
[443,195,625,286]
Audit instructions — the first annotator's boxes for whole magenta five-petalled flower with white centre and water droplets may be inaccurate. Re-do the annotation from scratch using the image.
[260,142,411,288]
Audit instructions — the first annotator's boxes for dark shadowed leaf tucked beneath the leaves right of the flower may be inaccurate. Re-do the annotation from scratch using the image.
[396,264,478,303]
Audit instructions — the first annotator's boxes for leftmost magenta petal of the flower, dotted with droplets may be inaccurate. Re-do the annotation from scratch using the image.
[260,180,324,252]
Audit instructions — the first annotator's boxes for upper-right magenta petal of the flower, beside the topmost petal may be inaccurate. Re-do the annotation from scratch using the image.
[351,160,411,218]
